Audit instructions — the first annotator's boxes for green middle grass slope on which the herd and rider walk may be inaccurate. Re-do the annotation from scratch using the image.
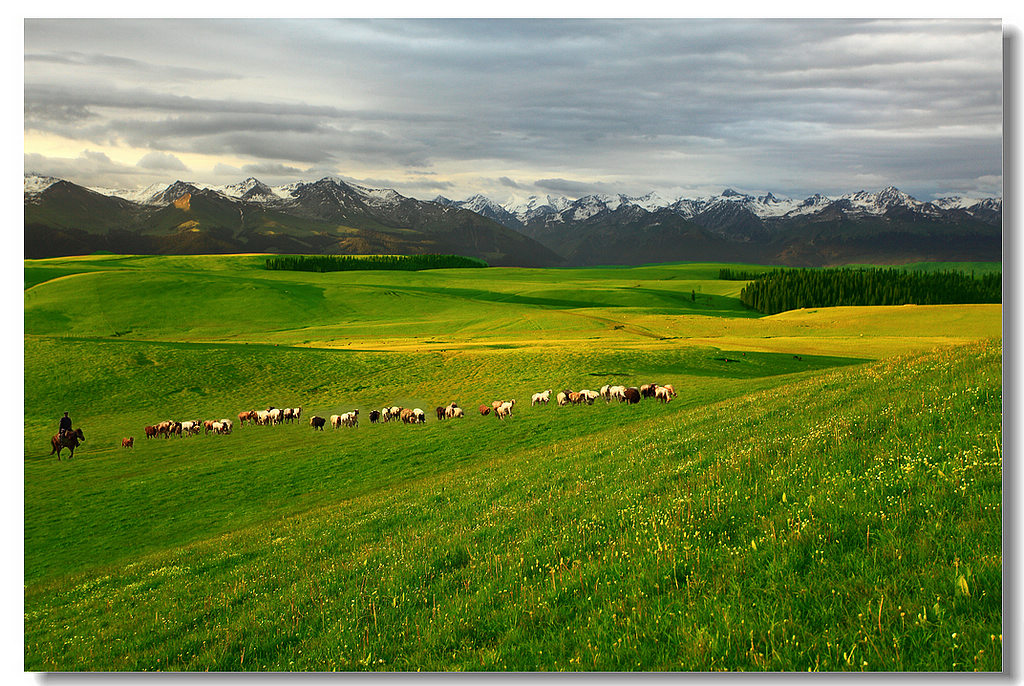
[25,339,855,581]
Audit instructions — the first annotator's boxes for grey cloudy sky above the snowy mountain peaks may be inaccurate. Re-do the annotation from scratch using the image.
[25,19,1002,202]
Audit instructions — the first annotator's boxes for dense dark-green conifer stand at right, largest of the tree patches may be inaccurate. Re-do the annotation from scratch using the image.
[739,267,1002,314]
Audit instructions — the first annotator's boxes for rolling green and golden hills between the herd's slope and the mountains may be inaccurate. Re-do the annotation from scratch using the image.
[25,255,1001,357]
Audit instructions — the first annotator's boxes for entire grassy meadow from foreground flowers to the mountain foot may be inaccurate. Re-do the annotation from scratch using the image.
[24,255,1002,671]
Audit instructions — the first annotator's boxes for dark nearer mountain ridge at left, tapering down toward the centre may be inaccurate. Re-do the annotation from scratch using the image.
[25,179,563,267]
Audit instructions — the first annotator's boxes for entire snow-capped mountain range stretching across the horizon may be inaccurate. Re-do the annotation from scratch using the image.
[25,174,1002,266]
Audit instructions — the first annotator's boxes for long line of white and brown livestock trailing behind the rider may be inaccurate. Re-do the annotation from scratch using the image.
[121,384,676,447]
